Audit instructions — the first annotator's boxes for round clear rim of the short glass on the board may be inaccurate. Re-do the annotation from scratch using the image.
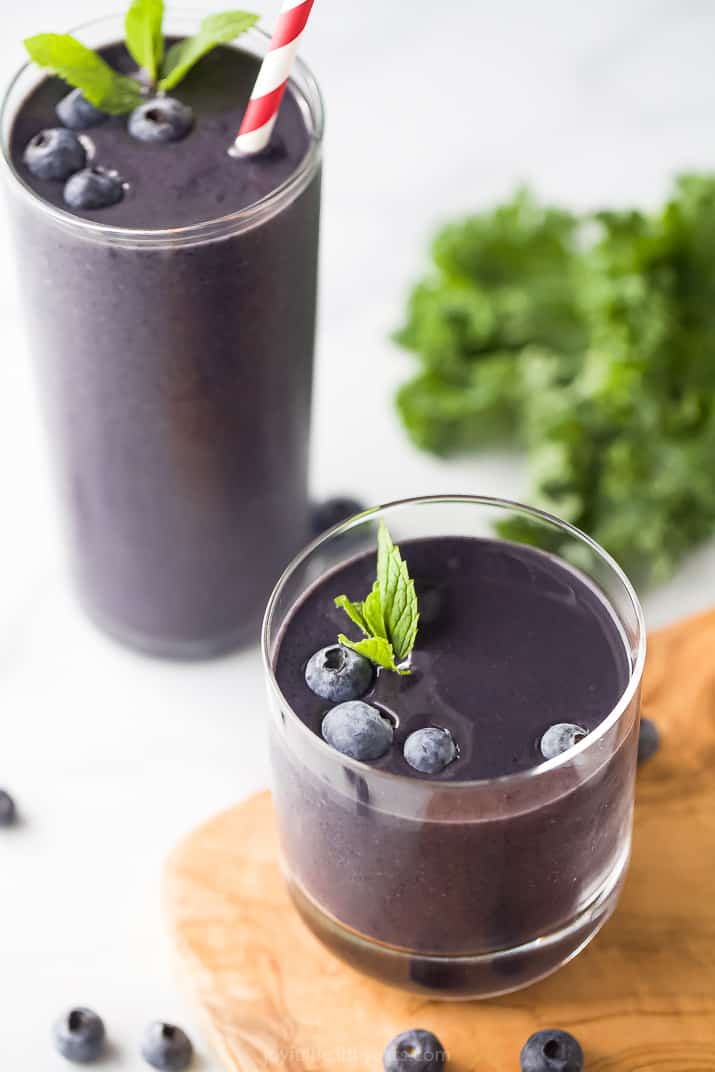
[260,494,647,792]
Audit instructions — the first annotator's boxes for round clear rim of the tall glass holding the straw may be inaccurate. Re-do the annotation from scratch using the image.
[0,8,325,247]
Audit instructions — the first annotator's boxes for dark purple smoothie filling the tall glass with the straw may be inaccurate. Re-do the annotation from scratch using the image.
[2,35,321,657]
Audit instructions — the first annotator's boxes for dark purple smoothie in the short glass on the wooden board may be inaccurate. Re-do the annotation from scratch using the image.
[272,537,637,994]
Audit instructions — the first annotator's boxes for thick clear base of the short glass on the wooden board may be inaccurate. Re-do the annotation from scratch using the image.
[288,847,629,1001]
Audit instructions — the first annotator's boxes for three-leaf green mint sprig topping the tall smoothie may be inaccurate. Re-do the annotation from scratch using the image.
[25,0,258,116]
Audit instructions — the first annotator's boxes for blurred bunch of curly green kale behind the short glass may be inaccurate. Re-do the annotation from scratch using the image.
[397,176,715,582]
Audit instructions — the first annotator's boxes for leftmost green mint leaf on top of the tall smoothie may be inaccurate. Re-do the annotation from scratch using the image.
[25,33,143,116]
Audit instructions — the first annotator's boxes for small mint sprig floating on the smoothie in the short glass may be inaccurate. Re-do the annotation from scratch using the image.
[336,521,419,674]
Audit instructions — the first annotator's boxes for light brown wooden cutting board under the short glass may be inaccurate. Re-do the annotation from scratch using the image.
[164,612,715,1072]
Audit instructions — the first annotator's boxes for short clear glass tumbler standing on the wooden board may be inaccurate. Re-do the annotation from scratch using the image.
[263,496,645,997]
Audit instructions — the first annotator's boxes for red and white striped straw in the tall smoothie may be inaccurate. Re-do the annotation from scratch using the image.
[234,0,315,155]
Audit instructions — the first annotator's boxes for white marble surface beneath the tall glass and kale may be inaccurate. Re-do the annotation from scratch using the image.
[0,0,715,1072]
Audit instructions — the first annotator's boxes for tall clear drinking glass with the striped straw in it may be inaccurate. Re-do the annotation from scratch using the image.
[1,13,323,658]
